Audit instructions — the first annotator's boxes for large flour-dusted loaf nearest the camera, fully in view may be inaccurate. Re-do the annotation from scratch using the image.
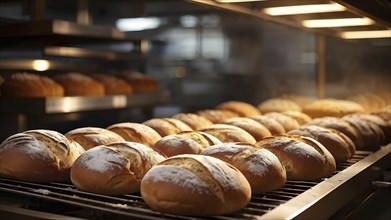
[141,154,251,216]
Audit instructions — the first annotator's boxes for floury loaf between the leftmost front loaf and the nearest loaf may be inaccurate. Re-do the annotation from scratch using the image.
[71,142,165,195]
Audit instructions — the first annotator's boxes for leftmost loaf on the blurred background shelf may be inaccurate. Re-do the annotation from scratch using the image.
[1,73,64,98]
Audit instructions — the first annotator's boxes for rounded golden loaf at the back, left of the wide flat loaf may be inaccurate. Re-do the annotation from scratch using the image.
[257,98,302,114]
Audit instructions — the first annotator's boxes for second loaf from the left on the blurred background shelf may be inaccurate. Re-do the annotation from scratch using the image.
[53,73,105,96]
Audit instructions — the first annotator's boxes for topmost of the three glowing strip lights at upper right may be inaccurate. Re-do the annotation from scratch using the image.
[263,3,346,16]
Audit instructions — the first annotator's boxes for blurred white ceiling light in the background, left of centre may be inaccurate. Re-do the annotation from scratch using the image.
[116,17,161,31]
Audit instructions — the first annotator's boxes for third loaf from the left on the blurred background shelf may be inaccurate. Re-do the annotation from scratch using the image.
[91,73,133,95]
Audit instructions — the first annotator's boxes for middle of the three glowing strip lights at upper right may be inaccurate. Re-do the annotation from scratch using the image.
[302,18,375,28]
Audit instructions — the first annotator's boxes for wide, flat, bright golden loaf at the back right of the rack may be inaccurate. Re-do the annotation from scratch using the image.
[303,99,364,118]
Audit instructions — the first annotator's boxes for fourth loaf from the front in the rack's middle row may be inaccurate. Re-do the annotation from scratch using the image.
[222,117,272,141]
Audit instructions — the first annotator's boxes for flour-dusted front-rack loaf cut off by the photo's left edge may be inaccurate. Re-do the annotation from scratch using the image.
[0,130,84,183]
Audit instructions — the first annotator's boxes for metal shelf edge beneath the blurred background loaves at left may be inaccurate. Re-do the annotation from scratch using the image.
[0,91,169,114]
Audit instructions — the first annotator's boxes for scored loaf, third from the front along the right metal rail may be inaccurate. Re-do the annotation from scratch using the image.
[256,135,336,180]
